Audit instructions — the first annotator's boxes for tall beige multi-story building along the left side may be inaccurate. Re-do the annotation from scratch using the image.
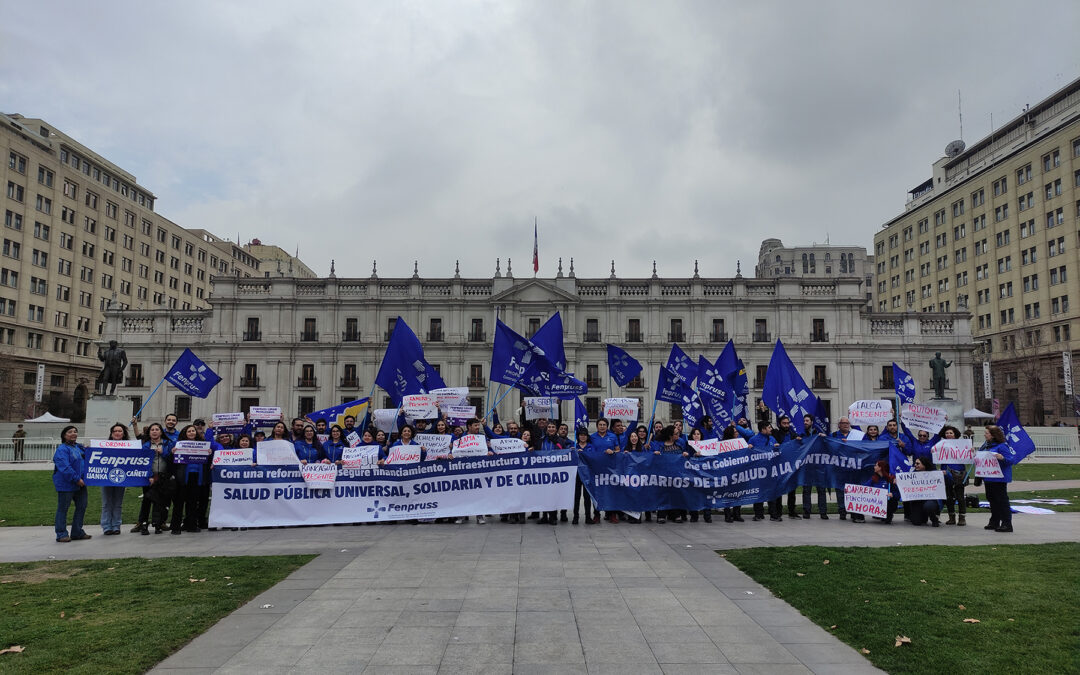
[0,114,265,420]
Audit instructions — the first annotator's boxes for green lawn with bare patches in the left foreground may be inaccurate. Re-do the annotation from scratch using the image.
[0,555,314,673]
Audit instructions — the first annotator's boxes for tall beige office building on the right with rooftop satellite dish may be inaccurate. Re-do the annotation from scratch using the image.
[874,80,1080,423]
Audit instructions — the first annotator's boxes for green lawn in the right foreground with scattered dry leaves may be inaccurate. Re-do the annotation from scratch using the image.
[723,543,1080,675]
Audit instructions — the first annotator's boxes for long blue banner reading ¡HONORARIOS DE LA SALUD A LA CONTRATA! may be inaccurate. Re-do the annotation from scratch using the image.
[577,436,889,511]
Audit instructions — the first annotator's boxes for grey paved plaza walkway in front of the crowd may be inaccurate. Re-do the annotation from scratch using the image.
[0,513,1080,675]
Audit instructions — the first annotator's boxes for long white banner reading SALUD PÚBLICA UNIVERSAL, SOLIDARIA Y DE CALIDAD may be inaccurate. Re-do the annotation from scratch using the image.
[210,453,578,527]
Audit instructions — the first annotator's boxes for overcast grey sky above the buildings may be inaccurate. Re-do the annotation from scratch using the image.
[0,0,1080,276]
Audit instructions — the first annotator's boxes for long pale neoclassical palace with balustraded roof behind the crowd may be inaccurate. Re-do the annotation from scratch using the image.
[104,267,972,420]
